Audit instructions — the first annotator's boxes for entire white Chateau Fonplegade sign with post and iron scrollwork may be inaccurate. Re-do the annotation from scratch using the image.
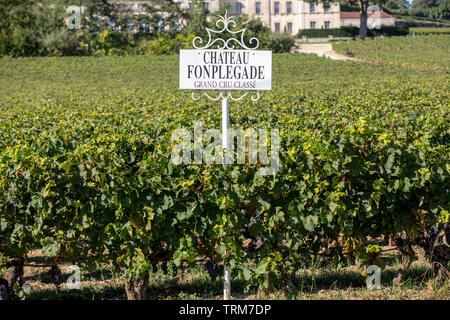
[180,12,272,300]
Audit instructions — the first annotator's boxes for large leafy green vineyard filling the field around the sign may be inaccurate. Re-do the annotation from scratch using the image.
[0,47,450,299]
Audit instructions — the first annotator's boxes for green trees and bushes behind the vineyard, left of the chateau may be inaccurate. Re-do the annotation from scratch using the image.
[0,0,294,57]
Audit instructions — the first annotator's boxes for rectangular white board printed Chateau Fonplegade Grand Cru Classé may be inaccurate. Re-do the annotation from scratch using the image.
[180,49,272,90]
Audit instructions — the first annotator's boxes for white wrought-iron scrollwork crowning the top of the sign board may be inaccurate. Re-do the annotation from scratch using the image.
[192,11,259,50]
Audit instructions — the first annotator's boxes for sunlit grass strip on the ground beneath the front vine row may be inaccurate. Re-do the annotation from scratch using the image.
[26,262,450,300]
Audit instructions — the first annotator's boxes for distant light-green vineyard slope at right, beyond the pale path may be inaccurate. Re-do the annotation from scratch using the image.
[333,34,450,72]
